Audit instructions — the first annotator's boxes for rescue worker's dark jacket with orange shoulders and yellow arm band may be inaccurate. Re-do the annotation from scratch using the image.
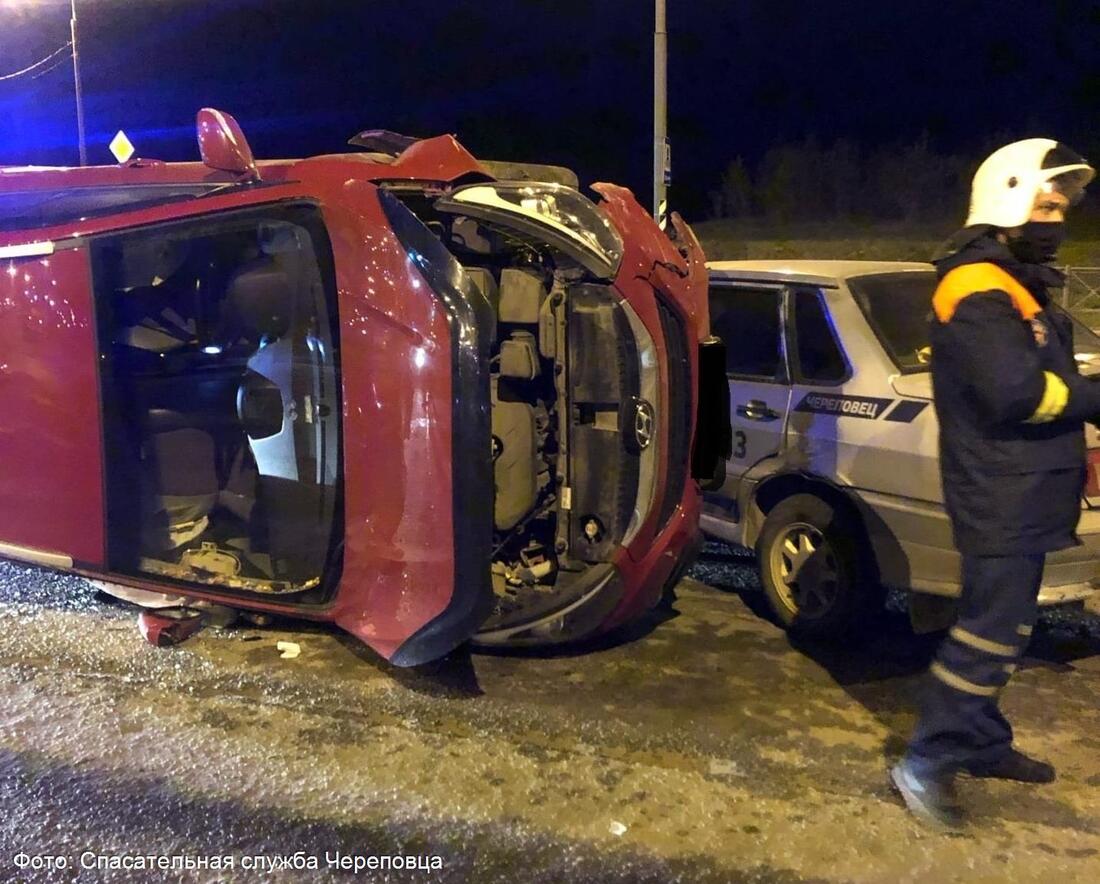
[931,234,1100,555]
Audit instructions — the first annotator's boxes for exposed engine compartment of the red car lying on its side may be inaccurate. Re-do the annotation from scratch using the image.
[398,192,657,643]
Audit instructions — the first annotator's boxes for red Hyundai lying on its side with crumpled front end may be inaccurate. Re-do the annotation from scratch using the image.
[0,109,728,665]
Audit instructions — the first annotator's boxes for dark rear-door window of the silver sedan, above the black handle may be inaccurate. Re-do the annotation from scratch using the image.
[711,286,780,379]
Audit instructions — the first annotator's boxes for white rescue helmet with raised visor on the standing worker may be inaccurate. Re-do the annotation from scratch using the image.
[966,139,1096,228]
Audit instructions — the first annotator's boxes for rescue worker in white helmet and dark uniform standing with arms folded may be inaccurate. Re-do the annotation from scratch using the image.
[890,139,1100,827]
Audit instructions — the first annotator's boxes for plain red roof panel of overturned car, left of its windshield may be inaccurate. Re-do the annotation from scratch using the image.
[0,245,103,568]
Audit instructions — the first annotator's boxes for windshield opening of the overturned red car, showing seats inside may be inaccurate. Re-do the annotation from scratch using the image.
[92,207,341,601]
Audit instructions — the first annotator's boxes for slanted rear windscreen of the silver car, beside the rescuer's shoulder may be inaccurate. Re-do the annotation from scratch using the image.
[848,269,936,372]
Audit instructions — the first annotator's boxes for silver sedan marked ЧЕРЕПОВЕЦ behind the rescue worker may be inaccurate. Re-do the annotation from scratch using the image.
[703,261,1100,636]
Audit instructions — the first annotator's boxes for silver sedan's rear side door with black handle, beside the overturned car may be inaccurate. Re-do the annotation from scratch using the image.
[710,283,791,500]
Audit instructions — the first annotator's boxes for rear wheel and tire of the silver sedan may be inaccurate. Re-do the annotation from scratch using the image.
[756,494,882,639]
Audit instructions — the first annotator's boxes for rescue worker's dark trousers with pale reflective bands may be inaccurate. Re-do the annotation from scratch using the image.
[906,555,1045,776]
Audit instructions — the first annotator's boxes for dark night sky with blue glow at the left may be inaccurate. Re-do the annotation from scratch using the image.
[0,0,1100,218]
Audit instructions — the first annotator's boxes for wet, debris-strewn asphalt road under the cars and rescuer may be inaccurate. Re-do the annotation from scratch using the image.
[0,538,1100,884]
